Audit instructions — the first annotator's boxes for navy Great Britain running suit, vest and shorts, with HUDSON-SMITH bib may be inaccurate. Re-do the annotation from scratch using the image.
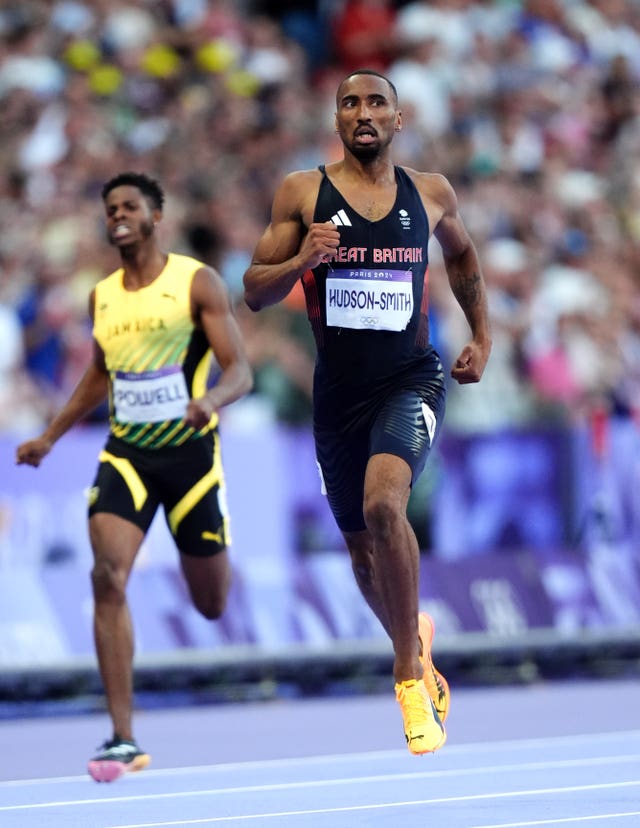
[303,167,446,532]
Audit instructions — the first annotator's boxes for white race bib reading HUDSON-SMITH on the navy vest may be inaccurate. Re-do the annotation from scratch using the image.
[327,269,413,331]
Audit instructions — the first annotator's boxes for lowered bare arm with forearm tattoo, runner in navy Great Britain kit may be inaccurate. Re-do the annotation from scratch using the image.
[414,174,491,384]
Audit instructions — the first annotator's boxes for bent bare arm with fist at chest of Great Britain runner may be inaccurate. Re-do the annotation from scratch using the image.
[244,170,340,311]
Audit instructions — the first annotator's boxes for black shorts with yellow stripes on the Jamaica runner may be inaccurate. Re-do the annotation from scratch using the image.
[89,429,231,557]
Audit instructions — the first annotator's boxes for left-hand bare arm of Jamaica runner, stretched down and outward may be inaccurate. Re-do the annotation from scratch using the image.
[16,291,109,467]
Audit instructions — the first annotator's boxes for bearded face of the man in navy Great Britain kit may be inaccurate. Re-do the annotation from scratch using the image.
[336,75,402,161]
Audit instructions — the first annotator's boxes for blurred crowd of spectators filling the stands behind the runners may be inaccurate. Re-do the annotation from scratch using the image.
[0,0,640,432]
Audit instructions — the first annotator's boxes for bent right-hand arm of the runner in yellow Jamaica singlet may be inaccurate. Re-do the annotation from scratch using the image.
[185,267,253,428]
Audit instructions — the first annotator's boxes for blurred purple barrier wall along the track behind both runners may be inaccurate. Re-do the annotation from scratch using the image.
[0,420,640,669]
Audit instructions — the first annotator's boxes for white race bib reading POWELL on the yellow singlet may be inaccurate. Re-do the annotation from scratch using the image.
[113,365,189,423]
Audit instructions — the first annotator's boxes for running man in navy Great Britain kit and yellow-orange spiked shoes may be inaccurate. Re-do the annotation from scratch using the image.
[244,69,491,754]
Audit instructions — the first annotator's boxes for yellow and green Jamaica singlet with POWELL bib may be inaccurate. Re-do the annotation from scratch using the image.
[93,253,218,449]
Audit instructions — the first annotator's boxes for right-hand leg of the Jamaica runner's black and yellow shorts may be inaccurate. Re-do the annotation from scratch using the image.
[161,429,231,557]
